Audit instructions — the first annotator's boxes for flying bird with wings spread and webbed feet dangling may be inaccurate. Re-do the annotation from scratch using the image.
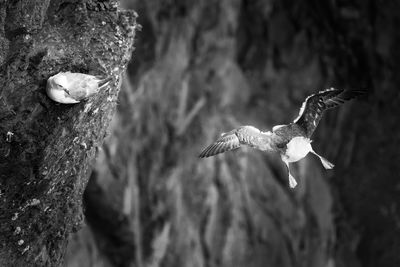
[199,88,365,188]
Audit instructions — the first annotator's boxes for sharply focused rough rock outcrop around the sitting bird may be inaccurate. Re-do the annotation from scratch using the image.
[0,1,136,266]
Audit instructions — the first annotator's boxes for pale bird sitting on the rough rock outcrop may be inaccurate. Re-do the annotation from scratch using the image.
[46,72,112,104]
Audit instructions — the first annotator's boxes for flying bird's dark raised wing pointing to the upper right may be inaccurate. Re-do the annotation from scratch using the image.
[293,88,366,138]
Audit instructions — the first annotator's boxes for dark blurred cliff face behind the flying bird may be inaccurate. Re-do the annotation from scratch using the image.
[66,0,400,267]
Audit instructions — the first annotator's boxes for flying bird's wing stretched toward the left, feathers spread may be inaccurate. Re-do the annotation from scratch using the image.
[199,126,272,158]
